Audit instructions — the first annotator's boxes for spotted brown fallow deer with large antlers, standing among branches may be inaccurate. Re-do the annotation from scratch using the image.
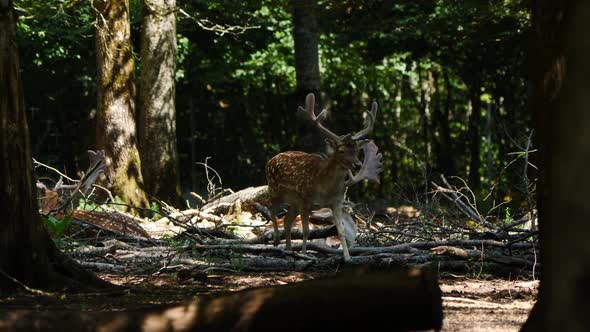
[266,93,382,261]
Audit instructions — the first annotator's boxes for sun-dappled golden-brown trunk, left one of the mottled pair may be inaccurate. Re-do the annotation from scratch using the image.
[93,0,149,213]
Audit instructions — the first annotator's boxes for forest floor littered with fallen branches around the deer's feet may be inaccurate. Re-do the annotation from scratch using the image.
[25,176,540,332]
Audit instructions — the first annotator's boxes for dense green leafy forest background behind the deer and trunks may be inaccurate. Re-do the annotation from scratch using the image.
[15,0,534,214]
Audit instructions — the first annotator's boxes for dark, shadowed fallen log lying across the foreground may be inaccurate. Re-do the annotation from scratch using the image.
[0,269,442,332]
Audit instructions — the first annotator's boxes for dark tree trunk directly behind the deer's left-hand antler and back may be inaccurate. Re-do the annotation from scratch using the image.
[291,0,324,151]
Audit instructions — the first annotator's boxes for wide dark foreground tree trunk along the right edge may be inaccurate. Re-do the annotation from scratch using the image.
[523,0,590,332]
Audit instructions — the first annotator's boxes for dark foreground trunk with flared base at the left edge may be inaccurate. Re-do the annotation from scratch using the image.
[0,0,107,291]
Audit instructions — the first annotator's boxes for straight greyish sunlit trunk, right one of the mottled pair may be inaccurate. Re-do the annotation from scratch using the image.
[139,0,180,204]
